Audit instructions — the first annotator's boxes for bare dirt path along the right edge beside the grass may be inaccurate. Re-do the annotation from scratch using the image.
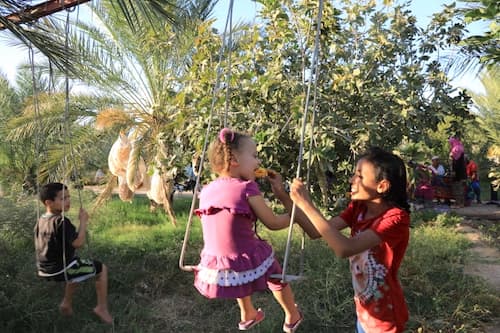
[455,205,500,333]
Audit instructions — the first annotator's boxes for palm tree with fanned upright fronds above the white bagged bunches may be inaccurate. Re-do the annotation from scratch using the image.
[46,0,215,223]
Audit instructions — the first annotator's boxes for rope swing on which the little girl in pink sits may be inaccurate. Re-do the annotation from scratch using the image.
[179,0,323,283]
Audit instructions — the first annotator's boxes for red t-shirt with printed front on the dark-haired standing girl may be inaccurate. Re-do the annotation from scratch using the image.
[340,201,410,333]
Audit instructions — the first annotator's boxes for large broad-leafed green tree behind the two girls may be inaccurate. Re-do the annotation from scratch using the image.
[179,1,470,206]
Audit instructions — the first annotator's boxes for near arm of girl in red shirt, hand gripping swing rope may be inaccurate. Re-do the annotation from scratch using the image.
[290,179,382,258]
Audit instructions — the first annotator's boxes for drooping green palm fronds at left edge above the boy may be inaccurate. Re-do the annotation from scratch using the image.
[0,65,116,190]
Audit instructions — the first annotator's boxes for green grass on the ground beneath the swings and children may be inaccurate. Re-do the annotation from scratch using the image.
[0,192,500,333]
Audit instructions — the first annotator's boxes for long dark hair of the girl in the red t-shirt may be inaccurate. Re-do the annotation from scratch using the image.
[360,147,410,212]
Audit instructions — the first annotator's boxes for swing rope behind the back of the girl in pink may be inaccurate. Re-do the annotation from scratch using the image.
[179,0,234,272]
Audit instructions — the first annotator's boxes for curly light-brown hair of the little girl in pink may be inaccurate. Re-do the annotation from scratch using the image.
[208,129,250,173]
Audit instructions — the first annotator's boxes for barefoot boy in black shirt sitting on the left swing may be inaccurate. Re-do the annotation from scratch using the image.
[35,183,113,324]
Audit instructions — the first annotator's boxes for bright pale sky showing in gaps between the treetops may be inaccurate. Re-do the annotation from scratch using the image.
[0,0,485,91]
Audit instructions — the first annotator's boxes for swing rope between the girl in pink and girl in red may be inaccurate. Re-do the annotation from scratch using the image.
[278,0,323,283]
